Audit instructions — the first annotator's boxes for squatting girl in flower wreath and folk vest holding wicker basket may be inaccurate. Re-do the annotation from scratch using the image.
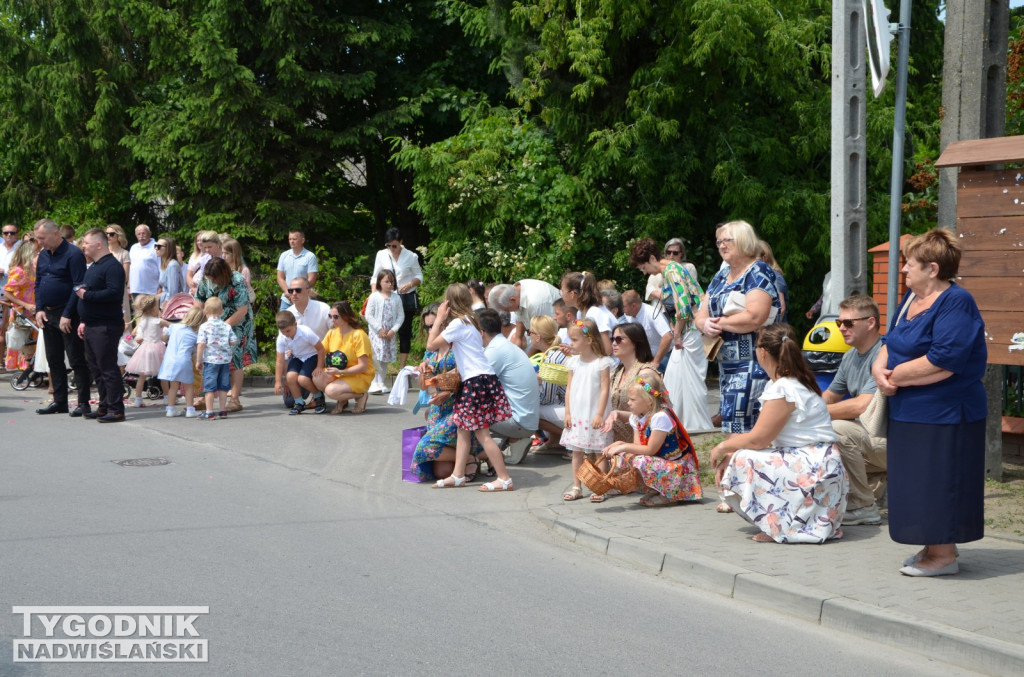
[603,374,703,507]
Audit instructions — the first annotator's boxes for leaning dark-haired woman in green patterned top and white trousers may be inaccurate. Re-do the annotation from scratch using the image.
[630,238,713,430]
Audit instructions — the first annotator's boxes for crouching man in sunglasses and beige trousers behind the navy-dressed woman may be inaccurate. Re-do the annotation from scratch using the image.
[822,294,886,526]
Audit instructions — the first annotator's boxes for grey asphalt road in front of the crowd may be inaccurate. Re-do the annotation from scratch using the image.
[0,383,969,677]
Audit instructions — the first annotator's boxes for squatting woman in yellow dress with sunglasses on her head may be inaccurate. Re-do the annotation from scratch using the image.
[313,301,374,414]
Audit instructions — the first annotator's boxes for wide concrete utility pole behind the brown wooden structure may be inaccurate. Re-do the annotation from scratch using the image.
[938,0,1010,479]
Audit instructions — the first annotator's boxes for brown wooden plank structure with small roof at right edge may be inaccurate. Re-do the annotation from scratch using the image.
[935,136,1024,365]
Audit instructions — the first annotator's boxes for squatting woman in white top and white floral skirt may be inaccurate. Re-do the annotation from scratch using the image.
[711,325,849,543]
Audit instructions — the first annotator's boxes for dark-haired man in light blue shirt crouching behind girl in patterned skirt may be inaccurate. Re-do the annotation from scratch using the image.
[476,308,541,439]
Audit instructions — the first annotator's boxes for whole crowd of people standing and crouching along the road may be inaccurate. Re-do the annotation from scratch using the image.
[0,219,986,577]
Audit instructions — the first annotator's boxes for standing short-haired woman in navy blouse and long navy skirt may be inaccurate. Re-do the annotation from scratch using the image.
[871,228,988,577]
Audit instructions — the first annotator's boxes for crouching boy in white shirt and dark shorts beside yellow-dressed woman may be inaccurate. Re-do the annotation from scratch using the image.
[273,310,327,416]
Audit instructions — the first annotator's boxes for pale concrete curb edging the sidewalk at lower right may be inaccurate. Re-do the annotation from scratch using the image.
[527,510,1024,675]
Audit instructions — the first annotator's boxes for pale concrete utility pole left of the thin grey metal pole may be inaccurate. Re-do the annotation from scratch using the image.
[829,0,869,308]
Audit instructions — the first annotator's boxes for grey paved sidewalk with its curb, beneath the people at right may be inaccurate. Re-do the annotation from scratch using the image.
[524,450,1024,675]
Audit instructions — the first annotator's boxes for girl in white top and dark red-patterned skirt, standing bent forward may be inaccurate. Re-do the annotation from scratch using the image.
[426,283,515,492]
